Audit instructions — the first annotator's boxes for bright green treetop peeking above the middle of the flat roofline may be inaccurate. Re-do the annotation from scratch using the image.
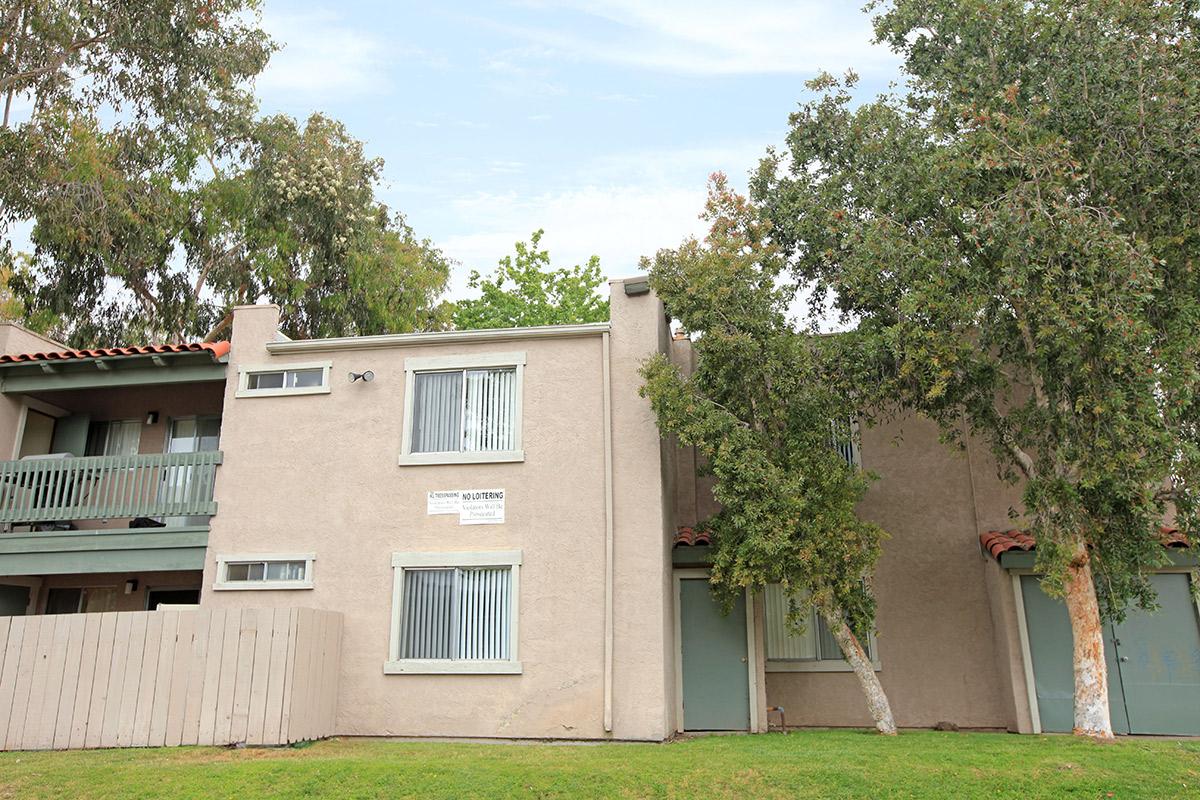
[454,230,608,330]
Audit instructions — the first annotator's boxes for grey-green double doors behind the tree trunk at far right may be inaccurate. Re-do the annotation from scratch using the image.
[1021,573,1200,735]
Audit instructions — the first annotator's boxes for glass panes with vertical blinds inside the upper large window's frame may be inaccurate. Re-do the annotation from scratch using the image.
[410,367,517,453]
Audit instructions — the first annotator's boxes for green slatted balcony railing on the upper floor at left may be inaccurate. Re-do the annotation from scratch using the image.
[0,450,222,524]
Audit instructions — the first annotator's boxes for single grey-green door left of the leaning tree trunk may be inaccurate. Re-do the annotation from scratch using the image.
[679,578,750,730]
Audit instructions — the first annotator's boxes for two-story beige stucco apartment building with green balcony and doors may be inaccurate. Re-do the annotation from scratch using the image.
[0,278,1200,740]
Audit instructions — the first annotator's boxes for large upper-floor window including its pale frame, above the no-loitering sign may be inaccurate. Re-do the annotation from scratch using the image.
[400,353,524,464]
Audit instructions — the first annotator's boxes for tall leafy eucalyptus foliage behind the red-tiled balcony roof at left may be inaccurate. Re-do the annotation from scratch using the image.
[0,0,449,345]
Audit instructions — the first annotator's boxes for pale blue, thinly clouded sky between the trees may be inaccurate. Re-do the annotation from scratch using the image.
[257,0,899,297]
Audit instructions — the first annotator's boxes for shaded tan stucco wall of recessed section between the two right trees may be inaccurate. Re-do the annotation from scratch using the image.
[767,417,1013,728]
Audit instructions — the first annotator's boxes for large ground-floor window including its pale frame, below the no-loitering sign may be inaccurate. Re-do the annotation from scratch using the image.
[384,551,521,673]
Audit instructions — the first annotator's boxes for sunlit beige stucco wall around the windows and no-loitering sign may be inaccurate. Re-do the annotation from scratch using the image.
[202,285,673,739]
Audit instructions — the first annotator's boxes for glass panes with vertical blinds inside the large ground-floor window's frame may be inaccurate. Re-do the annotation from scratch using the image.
[400,566,512,661]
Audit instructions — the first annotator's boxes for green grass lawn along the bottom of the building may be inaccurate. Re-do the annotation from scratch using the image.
[0,730,1200,800]
